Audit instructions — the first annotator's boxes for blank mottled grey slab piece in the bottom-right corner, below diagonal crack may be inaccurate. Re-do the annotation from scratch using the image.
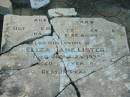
[76,56,130,97]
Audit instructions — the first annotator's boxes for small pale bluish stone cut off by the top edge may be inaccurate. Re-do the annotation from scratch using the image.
[30,0,50,9]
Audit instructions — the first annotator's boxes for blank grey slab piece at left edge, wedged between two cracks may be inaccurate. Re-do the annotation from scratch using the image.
[0,44,39,70]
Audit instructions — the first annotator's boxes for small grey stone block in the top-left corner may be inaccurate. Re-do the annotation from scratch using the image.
[0,0,12,15]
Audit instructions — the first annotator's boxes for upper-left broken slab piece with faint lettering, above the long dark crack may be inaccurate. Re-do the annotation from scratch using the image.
[1,15,51,52]
